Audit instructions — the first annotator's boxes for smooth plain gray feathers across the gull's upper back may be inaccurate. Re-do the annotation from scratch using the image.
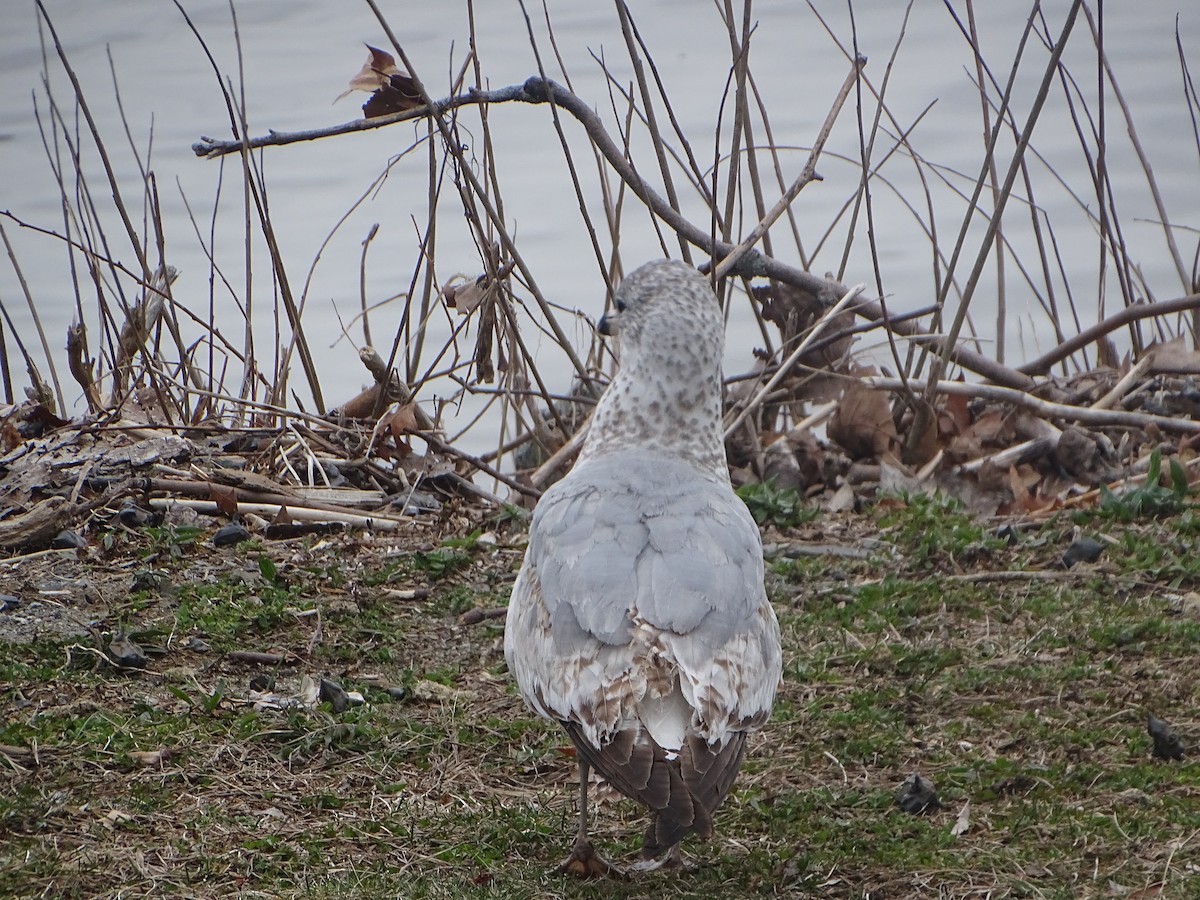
[529,452,763,646]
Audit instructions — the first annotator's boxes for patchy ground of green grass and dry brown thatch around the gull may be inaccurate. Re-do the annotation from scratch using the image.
[0,499,1200,898]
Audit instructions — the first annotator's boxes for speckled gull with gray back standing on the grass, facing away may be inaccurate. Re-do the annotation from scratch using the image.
[504,260,781,875]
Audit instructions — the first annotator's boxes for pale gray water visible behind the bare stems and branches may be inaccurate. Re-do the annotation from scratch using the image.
[0,0,1200,449]
